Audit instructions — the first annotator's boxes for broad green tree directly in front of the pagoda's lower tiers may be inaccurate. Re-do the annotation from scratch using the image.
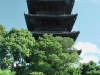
[30,34,79,75]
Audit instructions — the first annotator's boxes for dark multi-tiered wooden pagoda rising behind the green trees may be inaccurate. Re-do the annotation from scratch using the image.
[24,0,80,54]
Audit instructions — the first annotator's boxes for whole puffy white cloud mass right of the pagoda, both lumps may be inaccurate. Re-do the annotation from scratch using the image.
[75,42,100,63]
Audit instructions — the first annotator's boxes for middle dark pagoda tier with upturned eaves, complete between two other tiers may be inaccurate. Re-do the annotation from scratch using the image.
[25,14,77,32]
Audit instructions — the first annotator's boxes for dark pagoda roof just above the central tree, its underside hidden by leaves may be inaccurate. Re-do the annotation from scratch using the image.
[31,31,80,41]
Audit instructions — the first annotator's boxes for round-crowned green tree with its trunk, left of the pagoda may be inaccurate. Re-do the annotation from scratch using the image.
[3,28,35,75]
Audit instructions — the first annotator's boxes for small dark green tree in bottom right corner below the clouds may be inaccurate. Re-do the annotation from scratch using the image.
[81,61,100,75]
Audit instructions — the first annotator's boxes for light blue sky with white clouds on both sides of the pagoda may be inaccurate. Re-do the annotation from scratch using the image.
[0,0,100,63]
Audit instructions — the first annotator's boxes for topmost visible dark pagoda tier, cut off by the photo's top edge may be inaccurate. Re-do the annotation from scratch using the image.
[27,0,75,14]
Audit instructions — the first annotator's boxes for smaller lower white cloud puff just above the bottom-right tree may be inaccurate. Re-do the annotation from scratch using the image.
[80,55,99,63]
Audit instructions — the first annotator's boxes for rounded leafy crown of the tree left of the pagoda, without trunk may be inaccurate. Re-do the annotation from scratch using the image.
[5,28,35,57]
